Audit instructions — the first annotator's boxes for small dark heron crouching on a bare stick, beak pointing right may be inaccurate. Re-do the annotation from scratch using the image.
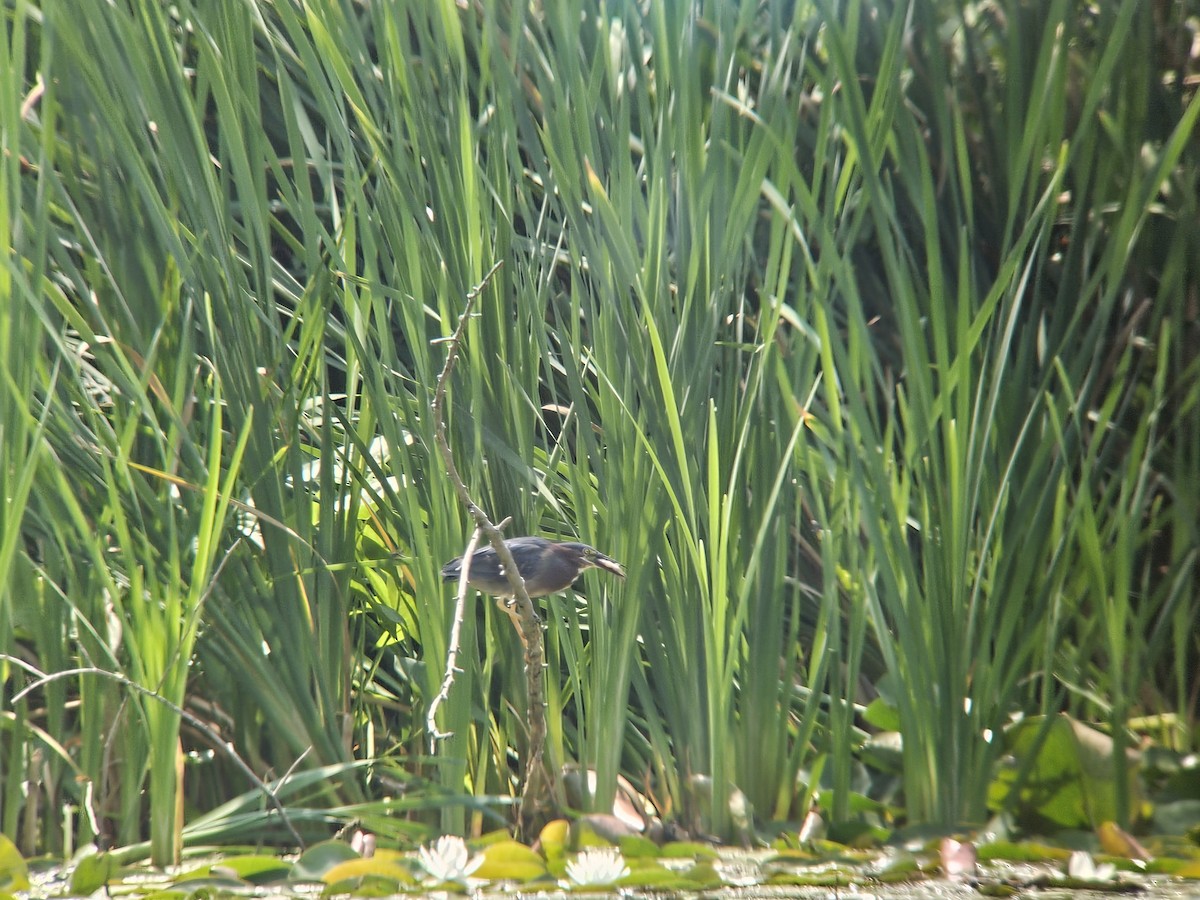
[442,538,625,599]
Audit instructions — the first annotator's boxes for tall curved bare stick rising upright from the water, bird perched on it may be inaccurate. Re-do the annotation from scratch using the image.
[432,260,557,838]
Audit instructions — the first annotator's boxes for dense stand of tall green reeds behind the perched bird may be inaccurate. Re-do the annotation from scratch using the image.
[0,0,1200,862]
